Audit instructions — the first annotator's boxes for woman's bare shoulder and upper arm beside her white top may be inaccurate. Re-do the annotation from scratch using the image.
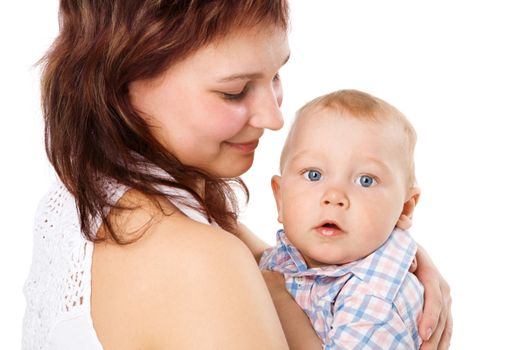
[92,192,285,349]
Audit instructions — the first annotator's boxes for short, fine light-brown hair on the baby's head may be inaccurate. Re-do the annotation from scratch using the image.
[281,90,417,188]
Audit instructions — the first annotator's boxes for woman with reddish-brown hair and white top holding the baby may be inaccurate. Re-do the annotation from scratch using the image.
[24,0,450,349]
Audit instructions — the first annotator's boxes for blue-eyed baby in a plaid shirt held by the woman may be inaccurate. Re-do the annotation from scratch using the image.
[260,90,423,349]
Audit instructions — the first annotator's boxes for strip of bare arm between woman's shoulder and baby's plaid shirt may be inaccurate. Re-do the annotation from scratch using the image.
[262,271,323,350]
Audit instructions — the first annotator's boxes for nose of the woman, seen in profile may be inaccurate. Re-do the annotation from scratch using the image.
[250,89,284,130]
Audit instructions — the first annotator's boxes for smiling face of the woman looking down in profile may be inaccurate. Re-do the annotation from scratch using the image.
[130,26,289,178]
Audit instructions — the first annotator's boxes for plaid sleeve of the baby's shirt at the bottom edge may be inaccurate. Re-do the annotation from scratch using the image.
[324,295,417,350]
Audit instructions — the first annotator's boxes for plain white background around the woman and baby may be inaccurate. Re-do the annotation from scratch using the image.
[0,0,525,349]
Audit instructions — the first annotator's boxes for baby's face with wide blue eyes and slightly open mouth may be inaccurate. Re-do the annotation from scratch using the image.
[272,109,414,267]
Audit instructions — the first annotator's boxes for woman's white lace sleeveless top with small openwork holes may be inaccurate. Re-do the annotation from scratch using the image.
[22,181,208,350]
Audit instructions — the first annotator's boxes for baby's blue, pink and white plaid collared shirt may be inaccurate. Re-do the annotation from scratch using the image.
[259,228,423,350]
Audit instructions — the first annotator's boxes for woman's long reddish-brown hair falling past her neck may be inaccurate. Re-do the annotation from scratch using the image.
[41,0,288,243]
